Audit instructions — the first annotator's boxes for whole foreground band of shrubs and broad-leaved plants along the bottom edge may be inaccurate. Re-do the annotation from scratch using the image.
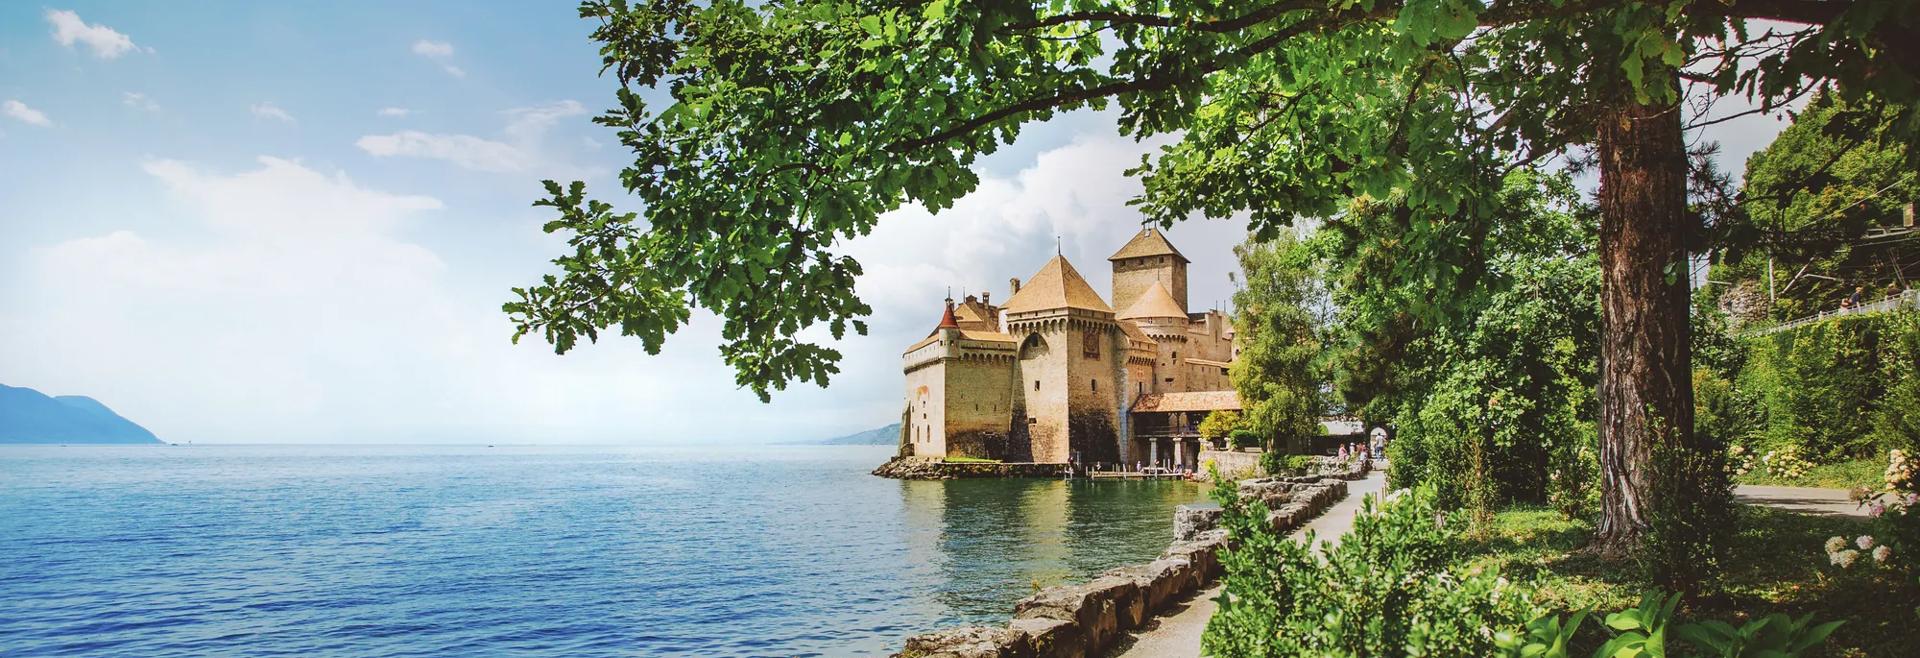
[1202,482,1841,658]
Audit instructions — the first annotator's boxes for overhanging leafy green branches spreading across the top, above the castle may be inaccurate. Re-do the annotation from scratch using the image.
[505,0,1920,397]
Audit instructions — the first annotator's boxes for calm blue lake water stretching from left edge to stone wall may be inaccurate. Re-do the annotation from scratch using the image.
[0,447,1202,656]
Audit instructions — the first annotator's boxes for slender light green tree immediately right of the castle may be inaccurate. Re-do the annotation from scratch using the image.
[1229,232,1325,453]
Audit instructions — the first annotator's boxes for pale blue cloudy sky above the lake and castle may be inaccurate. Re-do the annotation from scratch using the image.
[0,2,1784,443]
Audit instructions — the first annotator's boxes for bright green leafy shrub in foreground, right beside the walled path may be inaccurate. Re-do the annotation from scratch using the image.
[1200,483,1540,658]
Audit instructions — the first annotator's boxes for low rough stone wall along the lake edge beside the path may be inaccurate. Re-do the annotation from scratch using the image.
[893,478,1346,658]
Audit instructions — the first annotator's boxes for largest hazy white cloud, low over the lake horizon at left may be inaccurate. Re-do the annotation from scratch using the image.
[0,157,787,443]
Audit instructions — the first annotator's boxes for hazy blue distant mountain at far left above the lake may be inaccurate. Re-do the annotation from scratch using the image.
[0,384,161,443]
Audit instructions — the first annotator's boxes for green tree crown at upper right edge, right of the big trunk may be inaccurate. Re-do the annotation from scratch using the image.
[1709,94,1920,320]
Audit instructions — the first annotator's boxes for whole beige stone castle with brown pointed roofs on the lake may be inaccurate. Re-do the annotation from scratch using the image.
[900,228,1240,468]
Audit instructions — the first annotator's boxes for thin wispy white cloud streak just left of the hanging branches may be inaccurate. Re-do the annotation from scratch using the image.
[353,100,586,173]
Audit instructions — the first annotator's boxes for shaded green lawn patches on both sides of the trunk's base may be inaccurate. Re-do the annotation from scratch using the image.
[1469,506,1920,656]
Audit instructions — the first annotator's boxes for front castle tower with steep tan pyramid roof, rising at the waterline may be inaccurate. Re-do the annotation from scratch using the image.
[1002,255,1129,464]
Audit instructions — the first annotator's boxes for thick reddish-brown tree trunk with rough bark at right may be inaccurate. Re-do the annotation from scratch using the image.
[1594,78,1693,556]
